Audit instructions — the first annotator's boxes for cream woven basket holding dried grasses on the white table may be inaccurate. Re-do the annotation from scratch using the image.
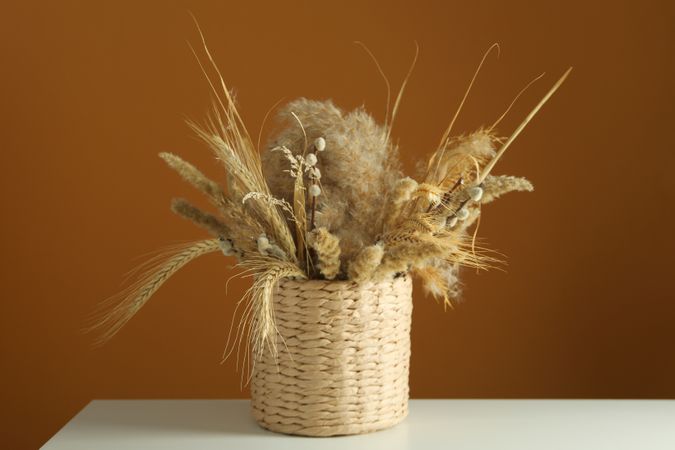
[251,276,412,436]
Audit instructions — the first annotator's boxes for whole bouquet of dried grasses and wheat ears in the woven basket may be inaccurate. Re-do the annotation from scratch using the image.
[90,37,571,370]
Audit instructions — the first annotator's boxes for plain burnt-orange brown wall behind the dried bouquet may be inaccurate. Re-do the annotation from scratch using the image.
[0,1,675,448]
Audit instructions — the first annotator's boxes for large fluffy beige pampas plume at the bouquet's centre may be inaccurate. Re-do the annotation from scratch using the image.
[262,99,401,262]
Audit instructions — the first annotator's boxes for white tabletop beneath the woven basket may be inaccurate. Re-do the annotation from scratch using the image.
[42,400,675,450]
